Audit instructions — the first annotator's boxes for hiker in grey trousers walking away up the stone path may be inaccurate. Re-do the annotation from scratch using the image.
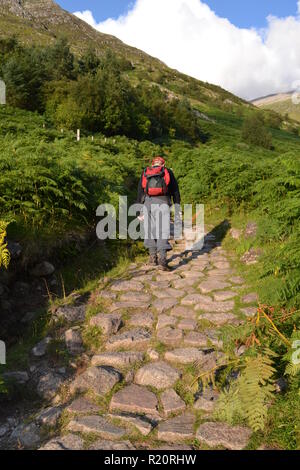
[138,156,180,271]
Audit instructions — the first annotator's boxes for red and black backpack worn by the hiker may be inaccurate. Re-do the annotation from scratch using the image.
[142,166,171,196]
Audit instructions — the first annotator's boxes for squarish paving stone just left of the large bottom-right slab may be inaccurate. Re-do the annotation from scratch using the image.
[157,414,195,442]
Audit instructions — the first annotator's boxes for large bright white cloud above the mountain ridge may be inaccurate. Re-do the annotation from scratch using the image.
[75,0,300,99]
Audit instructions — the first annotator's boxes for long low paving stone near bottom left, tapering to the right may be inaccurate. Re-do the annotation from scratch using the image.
[67,415,125,439]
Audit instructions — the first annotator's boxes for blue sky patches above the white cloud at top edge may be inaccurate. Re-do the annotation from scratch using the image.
[57,0,297,28]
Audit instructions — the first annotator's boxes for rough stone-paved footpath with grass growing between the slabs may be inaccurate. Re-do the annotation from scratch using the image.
[1,235,257,450]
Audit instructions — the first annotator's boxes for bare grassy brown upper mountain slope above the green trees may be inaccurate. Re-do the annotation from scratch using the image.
[0,0,249,106]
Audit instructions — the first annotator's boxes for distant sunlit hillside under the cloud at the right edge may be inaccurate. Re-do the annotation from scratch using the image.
[252,92,300,122]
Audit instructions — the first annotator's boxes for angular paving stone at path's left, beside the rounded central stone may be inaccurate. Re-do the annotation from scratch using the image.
[70,366,122,396]
